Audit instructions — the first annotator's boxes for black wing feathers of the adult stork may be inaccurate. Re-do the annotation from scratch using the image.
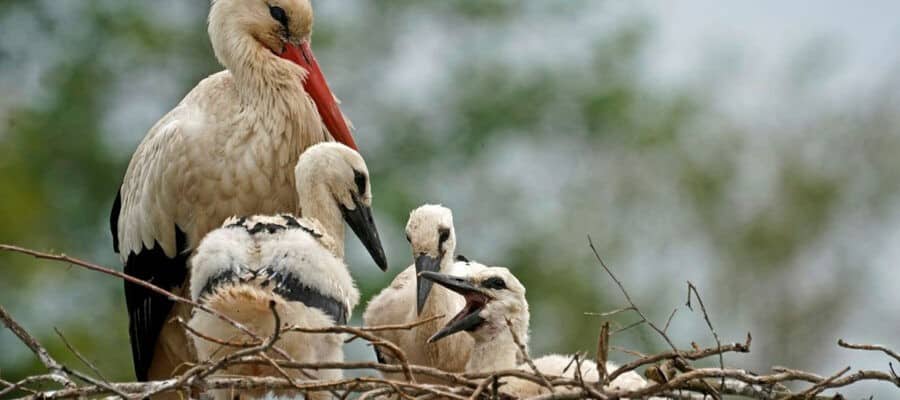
[121,227,190,381]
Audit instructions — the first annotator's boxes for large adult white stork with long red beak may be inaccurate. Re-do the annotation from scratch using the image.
[110,0,386,380]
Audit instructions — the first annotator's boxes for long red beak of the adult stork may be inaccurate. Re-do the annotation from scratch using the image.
[281,41,359,151]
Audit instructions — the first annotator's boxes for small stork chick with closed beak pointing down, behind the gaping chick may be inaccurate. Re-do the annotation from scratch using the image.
[363,204,473,382]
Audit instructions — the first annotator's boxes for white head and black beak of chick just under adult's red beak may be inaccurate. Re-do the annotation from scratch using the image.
[294,142,387,270]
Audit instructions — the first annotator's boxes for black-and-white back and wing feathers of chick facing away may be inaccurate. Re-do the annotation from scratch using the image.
[190,214,359,324]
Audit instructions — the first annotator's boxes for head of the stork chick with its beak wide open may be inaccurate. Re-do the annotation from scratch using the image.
[421,267,529,343]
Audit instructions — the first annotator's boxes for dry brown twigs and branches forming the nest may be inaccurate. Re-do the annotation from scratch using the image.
[0,242,900,400]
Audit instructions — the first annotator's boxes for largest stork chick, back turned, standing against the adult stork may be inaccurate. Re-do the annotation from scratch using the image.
[188,143,381,399]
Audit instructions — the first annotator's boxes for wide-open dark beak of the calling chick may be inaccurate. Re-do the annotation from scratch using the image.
[419,271,491,343]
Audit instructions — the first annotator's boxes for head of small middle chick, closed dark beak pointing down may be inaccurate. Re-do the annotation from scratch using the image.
[406,204,456,313]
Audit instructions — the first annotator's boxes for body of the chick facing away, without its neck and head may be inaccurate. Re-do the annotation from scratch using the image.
[189,215,359,399]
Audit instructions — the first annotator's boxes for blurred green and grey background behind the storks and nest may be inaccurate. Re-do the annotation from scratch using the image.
[0,0,900,398]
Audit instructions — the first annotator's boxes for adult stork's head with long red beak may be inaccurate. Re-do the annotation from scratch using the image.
[209,0,357,149]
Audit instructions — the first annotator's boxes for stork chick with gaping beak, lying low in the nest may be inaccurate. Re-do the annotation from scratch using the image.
[421,267,646,398]
